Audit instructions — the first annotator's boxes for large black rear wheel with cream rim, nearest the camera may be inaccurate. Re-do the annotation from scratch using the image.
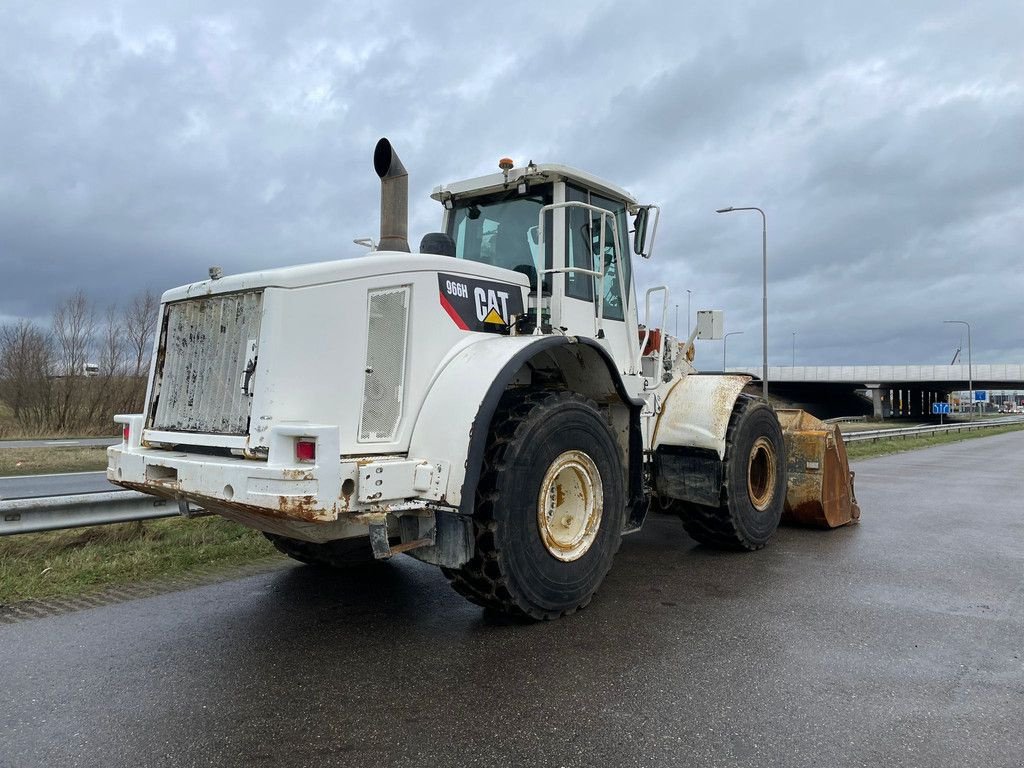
[442,392,626,621]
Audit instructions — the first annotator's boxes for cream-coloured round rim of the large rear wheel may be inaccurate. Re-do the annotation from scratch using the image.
[537,451,604,562]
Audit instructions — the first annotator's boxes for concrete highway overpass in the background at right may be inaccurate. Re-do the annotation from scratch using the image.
[729,364,1024,419]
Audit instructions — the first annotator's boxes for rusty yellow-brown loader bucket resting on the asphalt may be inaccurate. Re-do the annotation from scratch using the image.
[776,409,860,528]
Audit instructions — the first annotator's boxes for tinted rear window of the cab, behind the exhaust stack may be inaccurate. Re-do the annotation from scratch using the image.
[449,184,551,283]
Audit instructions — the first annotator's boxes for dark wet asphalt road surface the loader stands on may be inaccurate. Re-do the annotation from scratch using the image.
[0,432,1024,768]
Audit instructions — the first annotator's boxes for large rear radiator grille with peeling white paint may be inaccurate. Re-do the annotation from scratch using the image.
[152,292,263,435]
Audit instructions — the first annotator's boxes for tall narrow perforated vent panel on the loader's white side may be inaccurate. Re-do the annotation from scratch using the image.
[359,286,409,442]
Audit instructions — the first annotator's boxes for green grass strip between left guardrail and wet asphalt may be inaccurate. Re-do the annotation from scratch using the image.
[0,516,276,603]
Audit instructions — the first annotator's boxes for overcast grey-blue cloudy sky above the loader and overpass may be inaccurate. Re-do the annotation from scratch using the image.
[0,0,1024,369]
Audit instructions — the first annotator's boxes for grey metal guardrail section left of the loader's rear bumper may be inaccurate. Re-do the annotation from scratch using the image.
[0,490,178,536]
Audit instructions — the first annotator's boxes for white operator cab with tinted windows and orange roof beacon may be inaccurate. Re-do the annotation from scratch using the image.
[431,163,648,374]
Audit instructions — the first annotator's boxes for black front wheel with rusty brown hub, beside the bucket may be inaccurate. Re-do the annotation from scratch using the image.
[676,395,786,550]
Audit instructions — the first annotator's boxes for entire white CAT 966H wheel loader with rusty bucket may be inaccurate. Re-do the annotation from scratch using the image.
[108,139,859,618]
